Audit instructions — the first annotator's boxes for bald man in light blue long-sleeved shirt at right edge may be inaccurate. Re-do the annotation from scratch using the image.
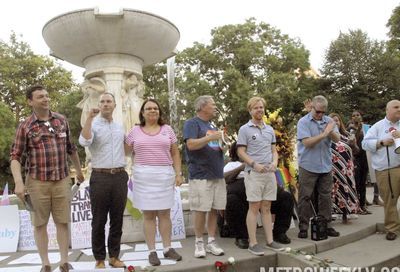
[362,100,400,240]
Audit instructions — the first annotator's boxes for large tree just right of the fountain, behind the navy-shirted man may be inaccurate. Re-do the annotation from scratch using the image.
[176,18,311,135]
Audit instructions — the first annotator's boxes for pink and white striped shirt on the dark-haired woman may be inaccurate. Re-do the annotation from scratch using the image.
[126,125,177,166]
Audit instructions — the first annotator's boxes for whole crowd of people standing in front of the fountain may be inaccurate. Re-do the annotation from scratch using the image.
[10,86,400,272]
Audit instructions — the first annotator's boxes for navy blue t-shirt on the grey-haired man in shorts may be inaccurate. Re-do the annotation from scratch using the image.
[183,117,224,179]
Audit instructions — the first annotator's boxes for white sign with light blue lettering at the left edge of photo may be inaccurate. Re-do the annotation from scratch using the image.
[0,205,19,253]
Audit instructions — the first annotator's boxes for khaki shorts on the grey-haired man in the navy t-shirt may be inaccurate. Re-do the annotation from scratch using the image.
[189,179,226,212]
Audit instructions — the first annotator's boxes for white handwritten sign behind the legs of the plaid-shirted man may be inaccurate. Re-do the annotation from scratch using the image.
[18,210,58,251]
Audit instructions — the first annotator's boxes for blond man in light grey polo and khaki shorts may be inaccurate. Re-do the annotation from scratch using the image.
[237,97,280,255]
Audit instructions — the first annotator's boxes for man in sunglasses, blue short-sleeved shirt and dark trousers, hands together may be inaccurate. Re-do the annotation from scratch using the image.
[297,95,340,238]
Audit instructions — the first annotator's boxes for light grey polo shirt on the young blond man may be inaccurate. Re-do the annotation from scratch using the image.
[237,120,276,171]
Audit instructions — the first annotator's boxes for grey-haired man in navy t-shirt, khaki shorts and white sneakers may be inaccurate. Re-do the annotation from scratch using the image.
[183,96,226,258]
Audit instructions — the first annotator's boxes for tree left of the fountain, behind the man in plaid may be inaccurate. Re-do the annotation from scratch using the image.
[0,33,74,122]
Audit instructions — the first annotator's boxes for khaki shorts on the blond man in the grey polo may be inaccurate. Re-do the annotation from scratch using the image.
[244,171,277,202]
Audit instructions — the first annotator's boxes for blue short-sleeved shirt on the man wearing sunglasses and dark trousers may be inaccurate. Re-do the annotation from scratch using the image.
[297,113,338,173]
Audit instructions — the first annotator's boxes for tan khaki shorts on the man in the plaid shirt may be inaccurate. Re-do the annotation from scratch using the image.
[26,176,71,227]
